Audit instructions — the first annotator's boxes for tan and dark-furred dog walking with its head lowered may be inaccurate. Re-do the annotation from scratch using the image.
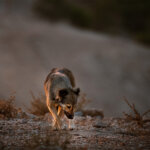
[44,68,80,129]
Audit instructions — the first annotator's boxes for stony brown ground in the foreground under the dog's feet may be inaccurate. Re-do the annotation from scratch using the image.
[0,113,150,150]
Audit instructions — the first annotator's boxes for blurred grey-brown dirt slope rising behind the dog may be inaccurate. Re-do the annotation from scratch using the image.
[0,0,150,116]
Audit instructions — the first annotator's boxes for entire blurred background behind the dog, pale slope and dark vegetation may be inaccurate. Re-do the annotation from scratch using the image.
[0,0,150,116]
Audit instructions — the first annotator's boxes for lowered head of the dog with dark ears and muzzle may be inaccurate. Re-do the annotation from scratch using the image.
[57,88,80,119]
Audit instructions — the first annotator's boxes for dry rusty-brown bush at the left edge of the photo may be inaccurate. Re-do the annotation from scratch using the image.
[0,95,18,119]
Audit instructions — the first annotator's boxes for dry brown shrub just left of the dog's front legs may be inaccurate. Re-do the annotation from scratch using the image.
[28,92,49,116]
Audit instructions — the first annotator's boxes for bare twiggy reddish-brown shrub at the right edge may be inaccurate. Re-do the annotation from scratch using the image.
[123,97,150,127]
